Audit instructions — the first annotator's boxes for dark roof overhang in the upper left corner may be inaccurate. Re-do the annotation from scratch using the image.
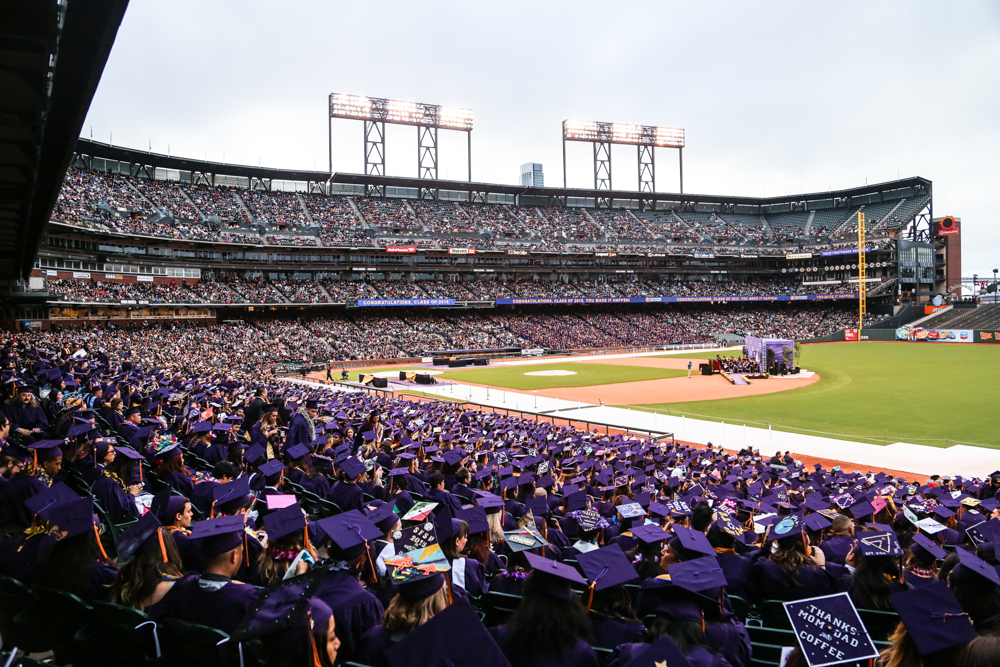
[0,0,128,281]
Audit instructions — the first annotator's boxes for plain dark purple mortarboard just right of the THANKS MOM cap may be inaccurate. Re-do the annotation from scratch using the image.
[892,581,978,655]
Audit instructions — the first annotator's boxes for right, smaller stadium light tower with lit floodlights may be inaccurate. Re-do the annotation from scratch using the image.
[563,120,684,210]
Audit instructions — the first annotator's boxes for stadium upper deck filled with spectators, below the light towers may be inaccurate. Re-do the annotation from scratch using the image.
[52,141,931,256]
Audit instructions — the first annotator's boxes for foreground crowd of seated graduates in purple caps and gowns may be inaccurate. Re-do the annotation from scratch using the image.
[0,328,1000,667]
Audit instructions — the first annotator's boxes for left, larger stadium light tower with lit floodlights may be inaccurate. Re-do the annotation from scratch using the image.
[327,93,472,199]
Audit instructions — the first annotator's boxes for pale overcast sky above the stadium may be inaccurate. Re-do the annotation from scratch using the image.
[84,0,1000,275]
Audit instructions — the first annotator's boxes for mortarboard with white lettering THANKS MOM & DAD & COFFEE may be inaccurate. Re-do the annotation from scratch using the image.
[784,593,879,667]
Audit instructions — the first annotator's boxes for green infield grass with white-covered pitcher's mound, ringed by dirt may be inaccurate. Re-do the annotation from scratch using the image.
[437,362,687,390]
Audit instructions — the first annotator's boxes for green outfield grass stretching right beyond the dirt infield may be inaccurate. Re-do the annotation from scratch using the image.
[631,343,1000,447]
